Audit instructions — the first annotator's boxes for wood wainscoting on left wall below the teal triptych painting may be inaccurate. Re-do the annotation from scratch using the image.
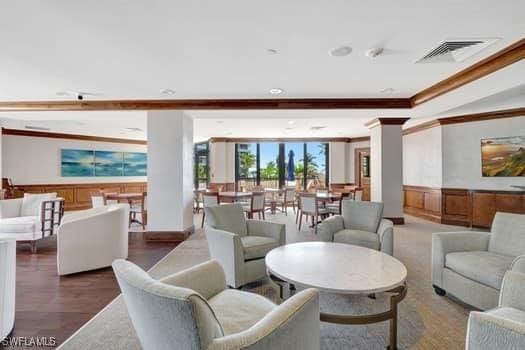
[12,182,147,210]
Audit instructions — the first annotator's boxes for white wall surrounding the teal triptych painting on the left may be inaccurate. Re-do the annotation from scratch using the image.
[1,135,147,185]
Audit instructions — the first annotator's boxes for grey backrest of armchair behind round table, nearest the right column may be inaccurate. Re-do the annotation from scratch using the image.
[341,200,383,232]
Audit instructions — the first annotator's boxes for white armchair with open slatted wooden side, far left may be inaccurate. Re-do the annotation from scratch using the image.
[0,193,64,253]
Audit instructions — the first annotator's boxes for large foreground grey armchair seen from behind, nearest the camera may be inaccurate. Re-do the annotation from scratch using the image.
[113,260,320,350]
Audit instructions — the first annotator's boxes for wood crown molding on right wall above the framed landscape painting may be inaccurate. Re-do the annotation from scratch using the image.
[403,107,525,135]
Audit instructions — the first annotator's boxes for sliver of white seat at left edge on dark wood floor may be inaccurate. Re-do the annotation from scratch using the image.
[0,239,16,340]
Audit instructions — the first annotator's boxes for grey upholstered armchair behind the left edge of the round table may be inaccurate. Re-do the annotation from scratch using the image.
[204,204,286,288]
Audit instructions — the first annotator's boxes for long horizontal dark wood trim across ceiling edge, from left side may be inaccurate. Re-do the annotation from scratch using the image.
[0,98,412,112]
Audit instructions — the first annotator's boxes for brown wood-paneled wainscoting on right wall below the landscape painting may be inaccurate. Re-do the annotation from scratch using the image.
[404,186,525,228]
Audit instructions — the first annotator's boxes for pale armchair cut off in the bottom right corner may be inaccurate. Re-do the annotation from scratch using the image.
[466,257,525,350]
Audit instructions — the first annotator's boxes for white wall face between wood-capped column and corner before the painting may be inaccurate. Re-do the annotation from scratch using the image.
[403,127,443,188]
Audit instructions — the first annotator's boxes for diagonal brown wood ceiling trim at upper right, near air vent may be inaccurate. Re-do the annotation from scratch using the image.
[410,39,525,107]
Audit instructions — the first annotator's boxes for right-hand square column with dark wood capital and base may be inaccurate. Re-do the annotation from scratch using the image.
[366,118,409,224]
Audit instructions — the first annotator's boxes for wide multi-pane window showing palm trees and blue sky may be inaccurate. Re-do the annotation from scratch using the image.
[235,142,328,191]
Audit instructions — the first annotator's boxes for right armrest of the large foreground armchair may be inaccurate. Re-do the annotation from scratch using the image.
[208,288,320,350]
